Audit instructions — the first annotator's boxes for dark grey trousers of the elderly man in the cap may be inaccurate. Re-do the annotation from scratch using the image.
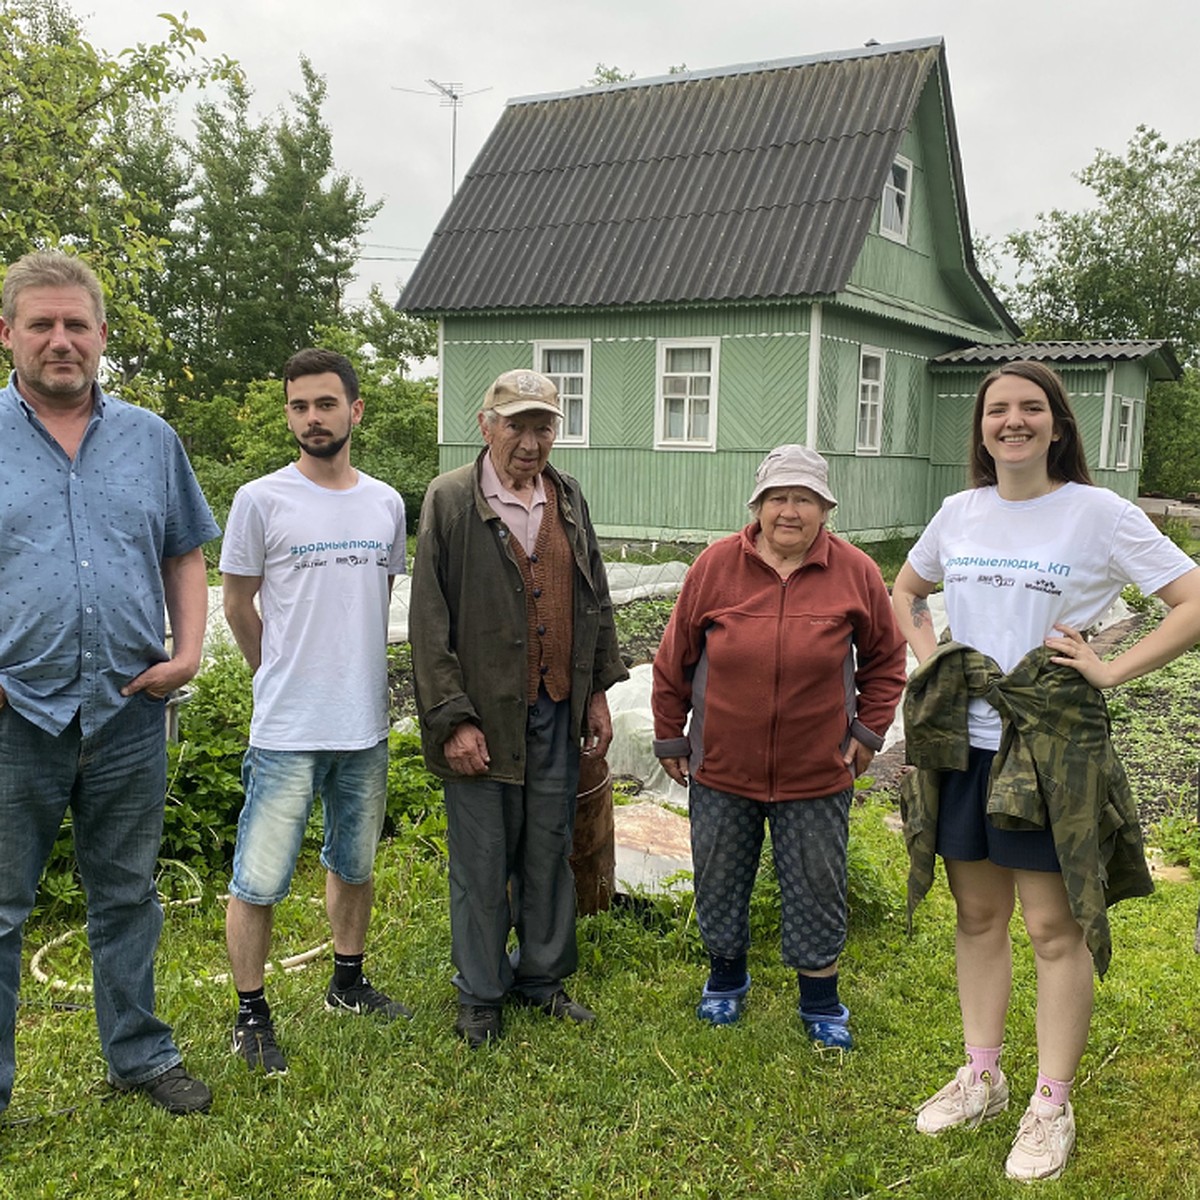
[444,692,580,1004]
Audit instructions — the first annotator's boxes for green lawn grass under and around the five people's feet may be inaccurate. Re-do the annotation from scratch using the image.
[9,798,1200,1200]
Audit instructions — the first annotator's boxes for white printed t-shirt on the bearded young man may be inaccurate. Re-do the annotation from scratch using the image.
[221,463,406,750]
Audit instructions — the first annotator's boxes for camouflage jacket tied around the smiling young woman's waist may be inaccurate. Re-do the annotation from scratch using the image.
[900,642,1153,977]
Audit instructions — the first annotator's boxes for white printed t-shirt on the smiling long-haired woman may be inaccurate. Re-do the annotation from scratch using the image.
[908,484,1196,750]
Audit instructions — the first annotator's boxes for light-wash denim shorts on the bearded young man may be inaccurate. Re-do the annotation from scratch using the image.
[229,738,388,905]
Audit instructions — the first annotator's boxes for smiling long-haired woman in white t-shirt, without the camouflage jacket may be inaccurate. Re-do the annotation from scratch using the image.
[893,361,1200,1180]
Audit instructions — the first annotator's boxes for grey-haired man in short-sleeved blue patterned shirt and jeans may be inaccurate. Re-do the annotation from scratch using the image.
[0,253,220,1114]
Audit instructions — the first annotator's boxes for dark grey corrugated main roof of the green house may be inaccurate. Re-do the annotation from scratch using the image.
[401,38,964,313]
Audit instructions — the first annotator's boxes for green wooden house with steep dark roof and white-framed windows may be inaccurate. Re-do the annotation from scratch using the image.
[400,38,1177,540]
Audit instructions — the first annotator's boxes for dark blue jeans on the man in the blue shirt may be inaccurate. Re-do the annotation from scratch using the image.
[0,692,180,1110]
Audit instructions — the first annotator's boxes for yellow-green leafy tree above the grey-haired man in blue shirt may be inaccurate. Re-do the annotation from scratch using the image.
[0,0,235,372]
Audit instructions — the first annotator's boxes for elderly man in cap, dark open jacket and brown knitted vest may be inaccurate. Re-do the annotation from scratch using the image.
[409,371,628,1046]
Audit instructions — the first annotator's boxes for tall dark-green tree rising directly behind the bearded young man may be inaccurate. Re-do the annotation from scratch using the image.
[148,58,379,418]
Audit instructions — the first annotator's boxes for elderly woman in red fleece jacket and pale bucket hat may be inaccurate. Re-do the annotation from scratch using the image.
[653,445,905,1050]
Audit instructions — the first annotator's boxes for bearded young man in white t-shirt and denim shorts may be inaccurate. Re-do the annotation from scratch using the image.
[221,349,412,1074]
